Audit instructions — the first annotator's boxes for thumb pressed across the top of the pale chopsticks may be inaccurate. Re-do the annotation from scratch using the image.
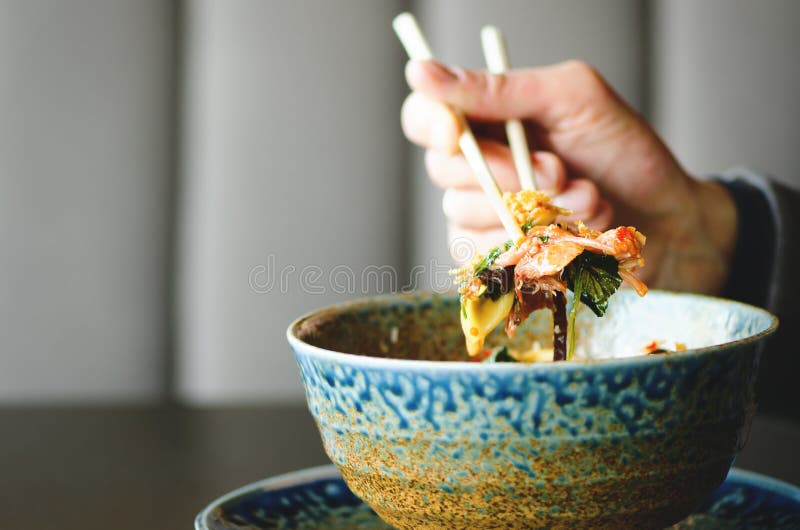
[406,61,613,129]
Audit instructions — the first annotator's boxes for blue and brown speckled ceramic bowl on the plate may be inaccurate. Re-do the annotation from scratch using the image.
[288,291,777,529]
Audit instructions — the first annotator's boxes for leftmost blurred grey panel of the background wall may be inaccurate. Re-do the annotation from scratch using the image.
[0,0,177,401]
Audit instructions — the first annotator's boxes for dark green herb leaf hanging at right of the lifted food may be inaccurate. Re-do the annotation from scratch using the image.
[562,250,622,317]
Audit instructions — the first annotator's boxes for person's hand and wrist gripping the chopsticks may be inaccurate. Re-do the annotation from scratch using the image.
[402,61,736,293]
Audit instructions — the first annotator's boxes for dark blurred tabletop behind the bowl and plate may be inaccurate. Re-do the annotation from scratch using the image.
[0,405,800,530]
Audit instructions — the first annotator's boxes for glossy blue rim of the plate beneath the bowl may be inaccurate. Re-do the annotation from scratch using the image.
[194,464,800,530]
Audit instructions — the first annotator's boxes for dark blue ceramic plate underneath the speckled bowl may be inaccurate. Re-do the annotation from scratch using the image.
[195,466,800,530]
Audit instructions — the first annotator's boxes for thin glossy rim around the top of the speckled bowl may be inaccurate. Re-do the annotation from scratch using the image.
[286,289,779,373]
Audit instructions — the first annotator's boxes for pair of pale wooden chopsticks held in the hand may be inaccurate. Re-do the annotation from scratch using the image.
[392,13,536,241]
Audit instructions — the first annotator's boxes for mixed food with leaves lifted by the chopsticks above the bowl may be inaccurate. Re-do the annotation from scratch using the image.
[453,190,647,362]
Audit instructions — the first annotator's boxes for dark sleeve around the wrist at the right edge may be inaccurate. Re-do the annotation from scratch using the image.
[717,169,800,419]
